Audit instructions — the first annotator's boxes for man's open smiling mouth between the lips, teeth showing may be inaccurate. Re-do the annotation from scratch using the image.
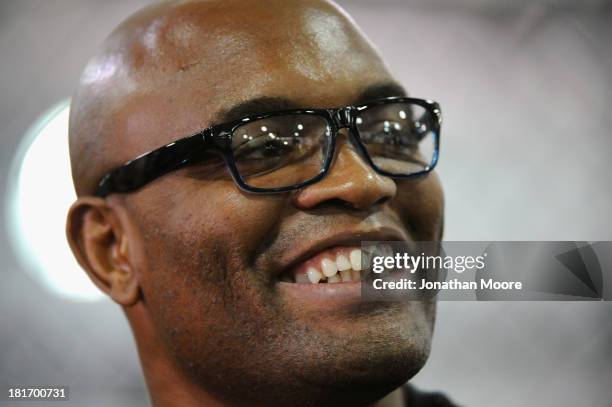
[281,246,363,284]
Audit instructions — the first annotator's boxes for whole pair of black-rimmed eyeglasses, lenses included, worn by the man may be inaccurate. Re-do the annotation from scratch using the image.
[95,97,442,197]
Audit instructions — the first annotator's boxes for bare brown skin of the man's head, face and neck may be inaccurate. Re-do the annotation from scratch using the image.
[67,0,443,406]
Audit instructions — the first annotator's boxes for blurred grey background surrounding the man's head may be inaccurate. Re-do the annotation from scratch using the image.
[0,0,612,407]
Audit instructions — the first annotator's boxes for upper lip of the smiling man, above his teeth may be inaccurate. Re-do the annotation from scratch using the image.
[275,227,408,277]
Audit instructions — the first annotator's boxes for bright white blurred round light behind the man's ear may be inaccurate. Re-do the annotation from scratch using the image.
[6,100,103,301]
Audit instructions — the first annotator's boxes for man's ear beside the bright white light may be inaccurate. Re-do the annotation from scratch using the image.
[66,197,140,306]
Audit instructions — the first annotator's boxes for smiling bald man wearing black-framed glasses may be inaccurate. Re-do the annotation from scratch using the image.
[67,0,448,407]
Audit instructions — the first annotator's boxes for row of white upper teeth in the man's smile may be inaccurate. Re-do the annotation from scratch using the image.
[294,248,361,284]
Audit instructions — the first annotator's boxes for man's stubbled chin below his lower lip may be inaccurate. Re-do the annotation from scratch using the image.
[278,302,435,393]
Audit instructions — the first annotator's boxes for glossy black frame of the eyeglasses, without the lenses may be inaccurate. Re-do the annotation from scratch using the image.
[95,97,442,197]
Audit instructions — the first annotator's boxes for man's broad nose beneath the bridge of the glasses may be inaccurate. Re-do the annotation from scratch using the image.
[294,134,397,209]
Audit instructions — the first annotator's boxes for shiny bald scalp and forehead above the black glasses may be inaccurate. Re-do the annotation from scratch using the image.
[70,0,388,196]
